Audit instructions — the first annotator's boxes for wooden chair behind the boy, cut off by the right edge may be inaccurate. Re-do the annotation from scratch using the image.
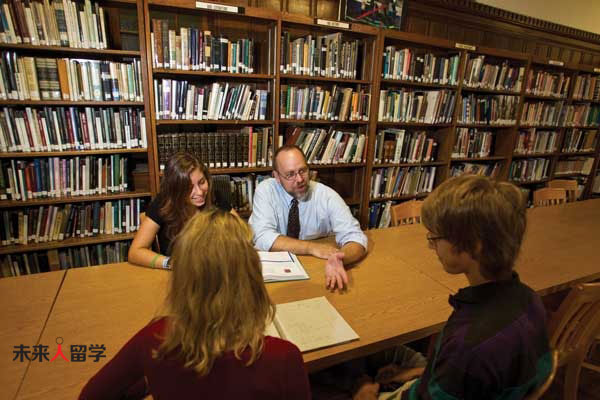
[548,283,600,400]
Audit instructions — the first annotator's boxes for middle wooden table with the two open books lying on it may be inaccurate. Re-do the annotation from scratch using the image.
[18,245,450,399]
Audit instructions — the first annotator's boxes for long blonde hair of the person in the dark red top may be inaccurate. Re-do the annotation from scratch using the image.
[154,209,275,376]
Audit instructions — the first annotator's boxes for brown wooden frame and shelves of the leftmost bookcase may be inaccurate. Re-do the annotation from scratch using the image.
[0,0,156,276]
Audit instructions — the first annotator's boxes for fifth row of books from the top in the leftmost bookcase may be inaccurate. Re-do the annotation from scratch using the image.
[0,198,145,246]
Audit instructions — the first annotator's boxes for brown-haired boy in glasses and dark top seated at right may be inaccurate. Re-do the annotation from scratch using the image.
[355,175,552,400]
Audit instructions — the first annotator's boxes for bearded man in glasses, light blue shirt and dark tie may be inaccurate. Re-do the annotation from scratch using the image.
[249,145,367,290]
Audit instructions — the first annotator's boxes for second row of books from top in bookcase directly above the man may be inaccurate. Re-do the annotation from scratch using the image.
[280,85,371,121]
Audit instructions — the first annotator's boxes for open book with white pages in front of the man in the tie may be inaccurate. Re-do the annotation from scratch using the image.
[258,251,309,282]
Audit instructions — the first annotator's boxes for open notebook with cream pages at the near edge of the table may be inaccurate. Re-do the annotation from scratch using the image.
[265,297,358,352]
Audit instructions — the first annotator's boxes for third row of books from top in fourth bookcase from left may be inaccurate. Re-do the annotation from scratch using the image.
[373,128,438,164]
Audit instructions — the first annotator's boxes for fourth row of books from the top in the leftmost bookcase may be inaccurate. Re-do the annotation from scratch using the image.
[0,154,129,201]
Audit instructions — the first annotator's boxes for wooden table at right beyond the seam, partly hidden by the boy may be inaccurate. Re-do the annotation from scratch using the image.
[386,199,600,296]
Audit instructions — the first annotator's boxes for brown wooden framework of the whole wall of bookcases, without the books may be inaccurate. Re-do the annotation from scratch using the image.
[0,0,600,276]
